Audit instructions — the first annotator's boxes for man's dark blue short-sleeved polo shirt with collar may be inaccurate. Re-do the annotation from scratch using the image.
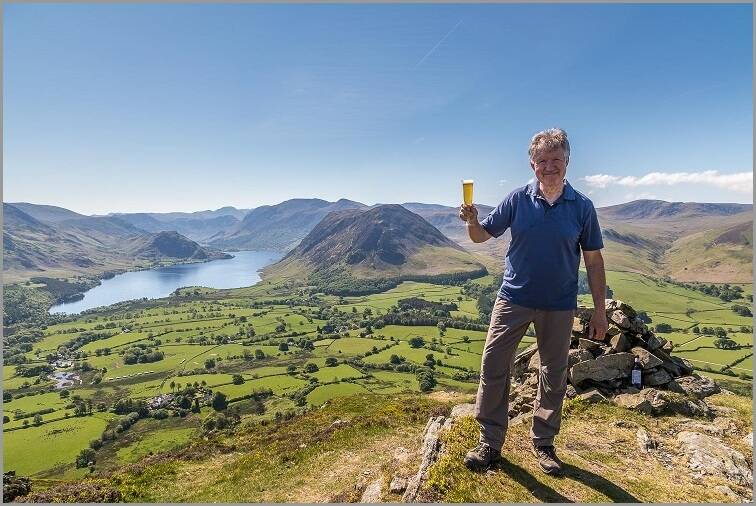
[480,179,604,309]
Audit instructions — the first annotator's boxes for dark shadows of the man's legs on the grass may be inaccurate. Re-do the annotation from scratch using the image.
[497,460,640,503]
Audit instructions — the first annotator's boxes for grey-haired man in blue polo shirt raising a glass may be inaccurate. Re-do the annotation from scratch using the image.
[459,128,608,474]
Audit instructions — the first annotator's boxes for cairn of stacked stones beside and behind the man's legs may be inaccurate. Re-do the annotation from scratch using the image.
[510,299,718,416]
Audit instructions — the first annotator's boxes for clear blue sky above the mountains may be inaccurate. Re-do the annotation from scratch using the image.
[3,4,753,214]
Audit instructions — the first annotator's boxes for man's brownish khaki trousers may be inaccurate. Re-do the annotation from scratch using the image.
[475,296,575,450]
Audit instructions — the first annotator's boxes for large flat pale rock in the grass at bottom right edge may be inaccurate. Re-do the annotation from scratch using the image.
[677,431,753,488]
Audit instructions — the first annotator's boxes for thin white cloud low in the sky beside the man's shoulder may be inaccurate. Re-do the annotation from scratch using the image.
[583,170,753,193]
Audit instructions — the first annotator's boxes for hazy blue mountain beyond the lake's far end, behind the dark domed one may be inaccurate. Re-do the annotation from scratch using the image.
[207,199,367,251]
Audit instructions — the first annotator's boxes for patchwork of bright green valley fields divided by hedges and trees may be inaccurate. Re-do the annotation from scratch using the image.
[3,272,753,479]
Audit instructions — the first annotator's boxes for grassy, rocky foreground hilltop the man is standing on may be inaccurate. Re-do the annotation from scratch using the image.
[10,392,752,503]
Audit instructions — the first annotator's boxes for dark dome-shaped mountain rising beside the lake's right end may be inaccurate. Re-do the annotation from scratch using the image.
[263,204,485,286]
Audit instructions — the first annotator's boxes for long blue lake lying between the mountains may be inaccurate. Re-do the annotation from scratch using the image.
[50,251,284,314]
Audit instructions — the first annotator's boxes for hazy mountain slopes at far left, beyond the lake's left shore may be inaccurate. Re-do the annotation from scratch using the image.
[3,203,227,283]
